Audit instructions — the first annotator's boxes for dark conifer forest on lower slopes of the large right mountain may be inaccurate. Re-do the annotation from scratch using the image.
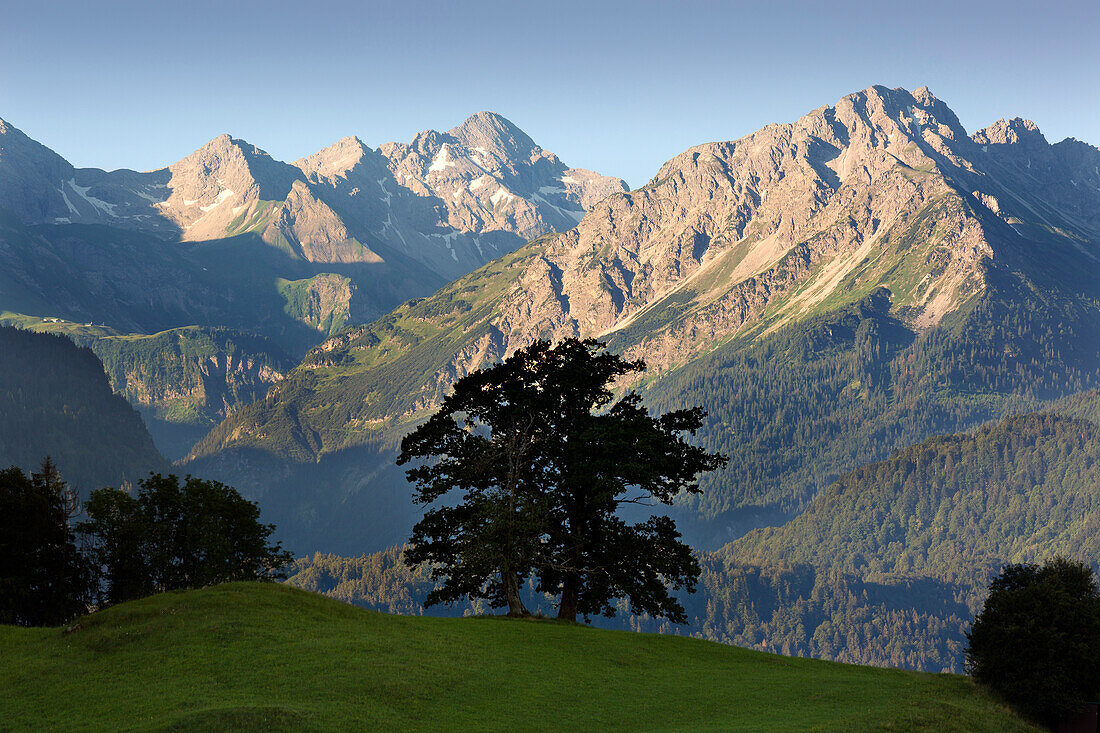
[647,270,1100,519]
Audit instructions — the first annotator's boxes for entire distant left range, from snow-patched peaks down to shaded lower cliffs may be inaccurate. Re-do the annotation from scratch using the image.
[0,112,626,456]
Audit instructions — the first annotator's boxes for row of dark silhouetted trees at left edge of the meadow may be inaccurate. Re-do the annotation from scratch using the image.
[0,458,292,626]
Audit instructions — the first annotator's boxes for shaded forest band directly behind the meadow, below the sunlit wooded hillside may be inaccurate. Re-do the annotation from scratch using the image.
[286,547,971,671]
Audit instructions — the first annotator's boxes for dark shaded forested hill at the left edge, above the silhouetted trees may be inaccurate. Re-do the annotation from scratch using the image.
[0,326,168,495]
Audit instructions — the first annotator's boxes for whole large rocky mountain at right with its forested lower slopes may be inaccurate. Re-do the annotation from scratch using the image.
[188,87,1100,551]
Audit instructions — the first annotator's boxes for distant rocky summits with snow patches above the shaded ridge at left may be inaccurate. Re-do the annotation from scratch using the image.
[0,112,626,281]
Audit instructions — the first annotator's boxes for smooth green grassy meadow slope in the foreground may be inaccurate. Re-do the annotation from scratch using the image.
[0,583,1035,731]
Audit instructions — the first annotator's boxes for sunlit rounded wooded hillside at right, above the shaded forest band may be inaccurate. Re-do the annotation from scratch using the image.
[723,414,1100,586]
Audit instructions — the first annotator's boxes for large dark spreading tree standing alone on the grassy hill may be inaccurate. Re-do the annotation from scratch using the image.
[398,338,725,620]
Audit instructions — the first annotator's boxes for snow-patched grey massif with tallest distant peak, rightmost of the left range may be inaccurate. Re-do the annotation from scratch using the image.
[295,112,626,280]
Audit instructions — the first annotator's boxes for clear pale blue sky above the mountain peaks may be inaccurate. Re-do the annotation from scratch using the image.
[0,0,1100,187]
